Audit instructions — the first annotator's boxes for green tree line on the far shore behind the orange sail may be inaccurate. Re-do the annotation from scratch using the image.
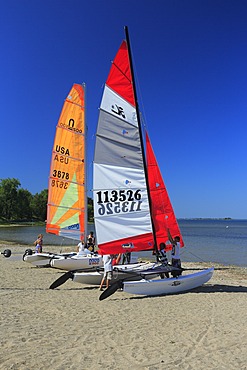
[0,178,93,222]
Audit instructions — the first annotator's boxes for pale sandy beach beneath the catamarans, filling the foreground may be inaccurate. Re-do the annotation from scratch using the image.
[0,243,247,370]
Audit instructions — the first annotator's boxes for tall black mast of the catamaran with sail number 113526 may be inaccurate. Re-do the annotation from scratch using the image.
[124,26,158,260]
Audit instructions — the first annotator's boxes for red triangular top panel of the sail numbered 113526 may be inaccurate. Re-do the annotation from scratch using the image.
[106,40,136,106]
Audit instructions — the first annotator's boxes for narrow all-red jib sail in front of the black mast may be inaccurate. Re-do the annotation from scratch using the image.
[146,133,184,249]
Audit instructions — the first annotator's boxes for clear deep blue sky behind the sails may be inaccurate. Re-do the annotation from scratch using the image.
[0,0,247,218]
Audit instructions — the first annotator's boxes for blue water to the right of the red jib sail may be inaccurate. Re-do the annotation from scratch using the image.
[179,220,247,267]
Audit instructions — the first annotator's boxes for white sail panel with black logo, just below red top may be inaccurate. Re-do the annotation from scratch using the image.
[100,85,138,127]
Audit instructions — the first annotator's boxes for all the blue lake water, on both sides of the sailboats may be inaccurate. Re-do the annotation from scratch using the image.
[0,220,247,267]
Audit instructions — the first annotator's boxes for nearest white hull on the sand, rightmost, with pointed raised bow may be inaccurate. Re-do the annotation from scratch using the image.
[123,268,214,296]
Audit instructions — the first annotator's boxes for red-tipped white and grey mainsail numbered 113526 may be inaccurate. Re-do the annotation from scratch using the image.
[93,41,154,254]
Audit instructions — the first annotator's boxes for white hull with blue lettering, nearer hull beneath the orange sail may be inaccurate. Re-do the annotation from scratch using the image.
[50,254,103,271]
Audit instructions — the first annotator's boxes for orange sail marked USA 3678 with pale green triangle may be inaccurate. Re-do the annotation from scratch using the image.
[46,84,87,240]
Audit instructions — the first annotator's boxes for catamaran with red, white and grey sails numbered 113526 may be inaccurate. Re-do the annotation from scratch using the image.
[93,27,213,299]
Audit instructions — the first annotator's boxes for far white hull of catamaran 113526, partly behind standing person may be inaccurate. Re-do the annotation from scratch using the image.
[72,262,157,285]
